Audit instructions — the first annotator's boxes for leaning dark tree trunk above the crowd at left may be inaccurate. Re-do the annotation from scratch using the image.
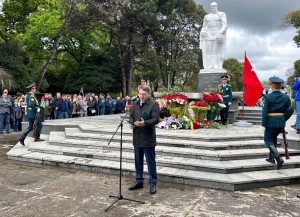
[36,4,74,92]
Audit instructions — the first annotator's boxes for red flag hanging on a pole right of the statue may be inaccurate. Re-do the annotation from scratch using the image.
[244,55,264,106]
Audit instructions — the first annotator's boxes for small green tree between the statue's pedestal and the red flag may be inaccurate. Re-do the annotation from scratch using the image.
[223,58,244,91]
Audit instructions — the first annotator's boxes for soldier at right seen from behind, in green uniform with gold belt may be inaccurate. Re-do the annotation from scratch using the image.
[262,77,294,169]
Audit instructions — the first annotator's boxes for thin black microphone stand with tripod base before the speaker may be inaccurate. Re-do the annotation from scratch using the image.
[105,113,145,212]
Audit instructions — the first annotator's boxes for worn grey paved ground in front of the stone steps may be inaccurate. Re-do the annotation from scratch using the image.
[0,129,300,217]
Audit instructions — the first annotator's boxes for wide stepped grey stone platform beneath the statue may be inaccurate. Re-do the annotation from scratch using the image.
[7,115,300,191]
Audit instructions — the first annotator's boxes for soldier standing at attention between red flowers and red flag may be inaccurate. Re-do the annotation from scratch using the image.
[218,75,232,125]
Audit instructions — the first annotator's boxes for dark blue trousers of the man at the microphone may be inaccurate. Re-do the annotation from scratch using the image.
[134,147,157,185]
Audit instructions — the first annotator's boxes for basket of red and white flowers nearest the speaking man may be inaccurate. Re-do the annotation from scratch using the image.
[161,94,188,118]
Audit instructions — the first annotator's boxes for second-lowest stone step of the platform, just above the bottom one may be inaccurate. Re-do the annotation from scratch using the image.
[28,141,300,173]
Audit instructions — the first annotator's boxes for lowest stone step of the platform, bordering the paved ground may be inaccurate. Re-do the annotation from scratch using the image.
[8,143,300,191]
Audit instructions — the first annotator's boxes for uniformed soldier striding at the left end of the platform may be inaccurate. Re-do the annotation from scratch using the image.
[19,83,44,146]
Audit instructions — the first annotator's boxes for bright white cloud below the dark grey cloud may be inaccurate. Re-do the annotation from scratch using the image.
[226,28,300,80]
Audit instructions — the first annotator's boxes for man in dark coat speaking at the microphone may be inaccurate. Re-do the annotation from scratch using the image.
[129,85,159,194]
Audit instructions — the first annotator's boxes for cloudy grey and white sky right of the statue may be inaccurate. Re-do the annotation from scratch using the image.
[194,0,300,81]
